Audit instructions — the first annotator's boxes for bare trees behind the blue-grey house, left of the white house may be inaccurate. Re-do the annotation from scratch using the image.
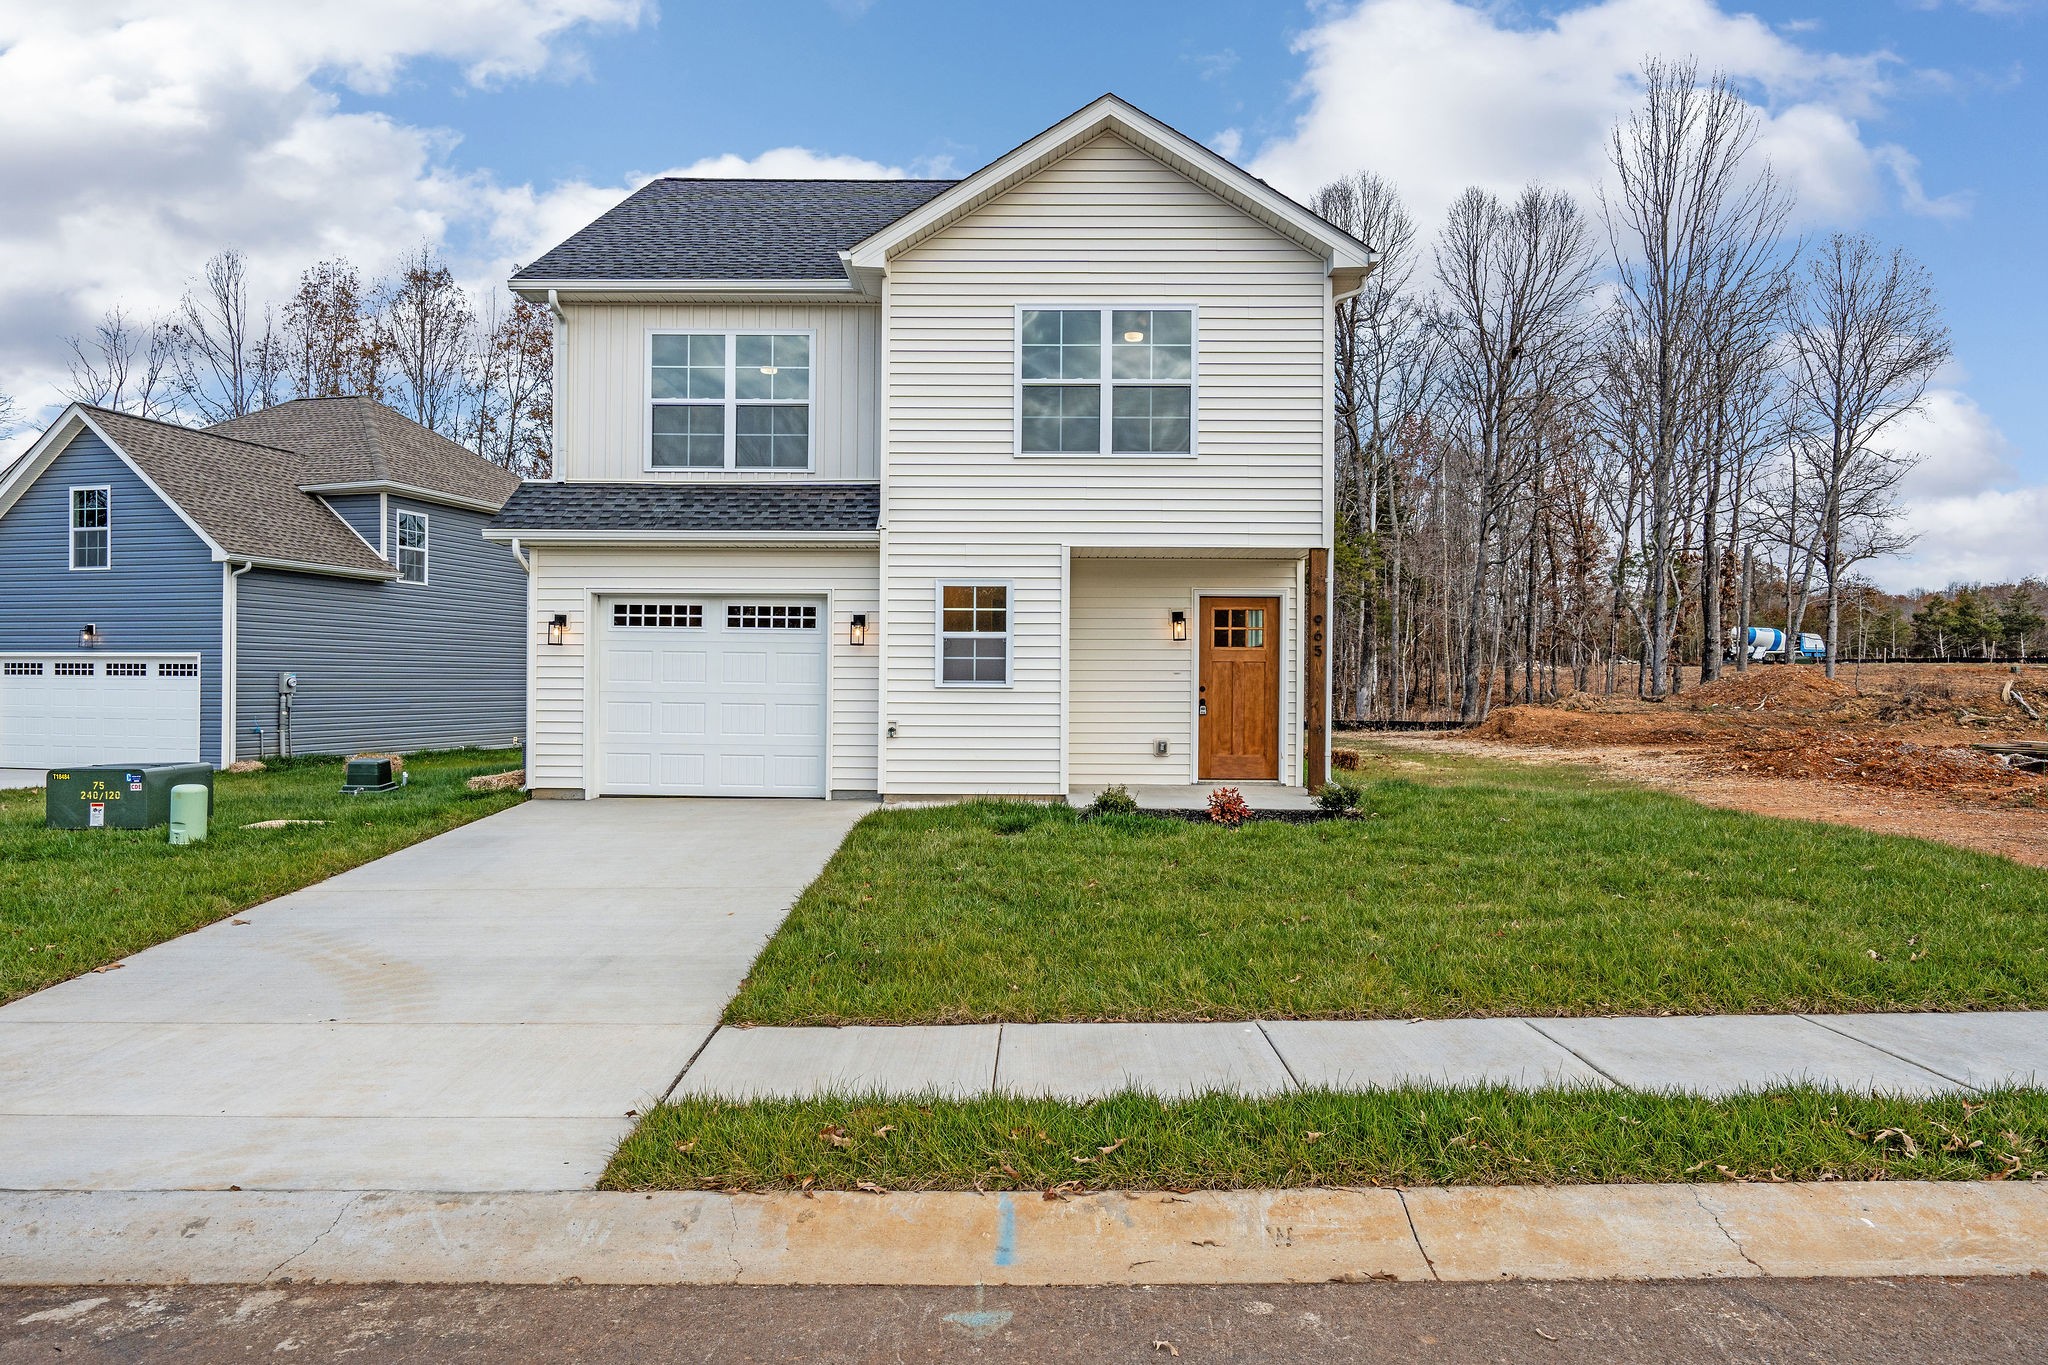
[63,248,555,479]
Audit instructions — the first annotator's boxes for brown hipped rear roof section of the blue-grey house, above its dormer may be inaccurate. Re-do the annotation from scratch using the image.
[207,397,518,505]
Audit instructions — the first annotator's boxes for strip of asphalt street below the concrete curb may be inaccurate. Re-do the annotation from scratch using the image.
[0,1279,2048,1365]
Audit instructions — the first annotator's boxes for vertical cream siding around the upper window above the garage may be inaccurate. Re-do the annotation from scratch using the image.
[557,303,881,483]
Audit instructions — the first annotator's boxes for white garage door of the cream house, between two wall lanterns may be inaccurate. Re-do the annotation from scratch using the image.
[600,598,829,796]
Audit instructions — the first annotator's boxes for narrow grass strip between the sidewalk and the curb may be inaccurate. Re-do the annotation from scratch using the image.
[600,1089,2048,1191]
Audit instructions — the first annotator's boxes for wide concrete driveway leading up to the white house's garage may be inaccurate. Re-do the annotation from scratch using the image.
[0,798,872,1191]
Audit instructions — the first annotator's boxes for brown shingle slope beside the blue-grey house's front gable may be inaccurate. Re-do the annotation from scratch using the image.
[86,407,391,575]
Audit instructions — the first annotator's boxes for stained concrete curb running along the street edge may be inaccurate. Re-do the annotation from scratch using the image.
[0,1181,2048,1285]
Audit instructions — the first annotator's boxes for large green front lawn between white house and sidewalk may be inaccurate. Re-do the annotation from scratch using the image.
[727,755,2048,1023]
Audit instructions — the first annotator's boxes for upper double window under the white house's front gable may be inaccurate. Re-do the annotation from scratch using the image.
[1018,307,1194,454]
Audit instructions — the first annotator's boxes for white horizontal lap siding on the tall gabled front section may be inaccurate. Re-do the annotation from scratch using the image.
[883,133,1331,794]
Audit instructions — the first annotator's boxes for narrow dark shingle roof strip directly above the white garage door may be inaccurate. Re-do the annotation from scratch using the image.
[492,483,883,534]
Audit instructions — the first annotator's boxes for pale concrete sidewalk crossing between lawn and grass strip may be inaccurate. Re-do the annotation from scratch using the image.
[674,1013,2048,1101]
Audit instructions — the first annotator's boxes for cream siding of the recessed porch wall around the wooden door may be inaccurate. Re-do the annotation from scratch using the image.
[1067,559,1303,786]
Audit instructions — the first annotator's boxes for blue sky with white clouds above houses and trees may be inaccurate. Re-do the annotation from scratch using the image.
[0,0,2048,585]
